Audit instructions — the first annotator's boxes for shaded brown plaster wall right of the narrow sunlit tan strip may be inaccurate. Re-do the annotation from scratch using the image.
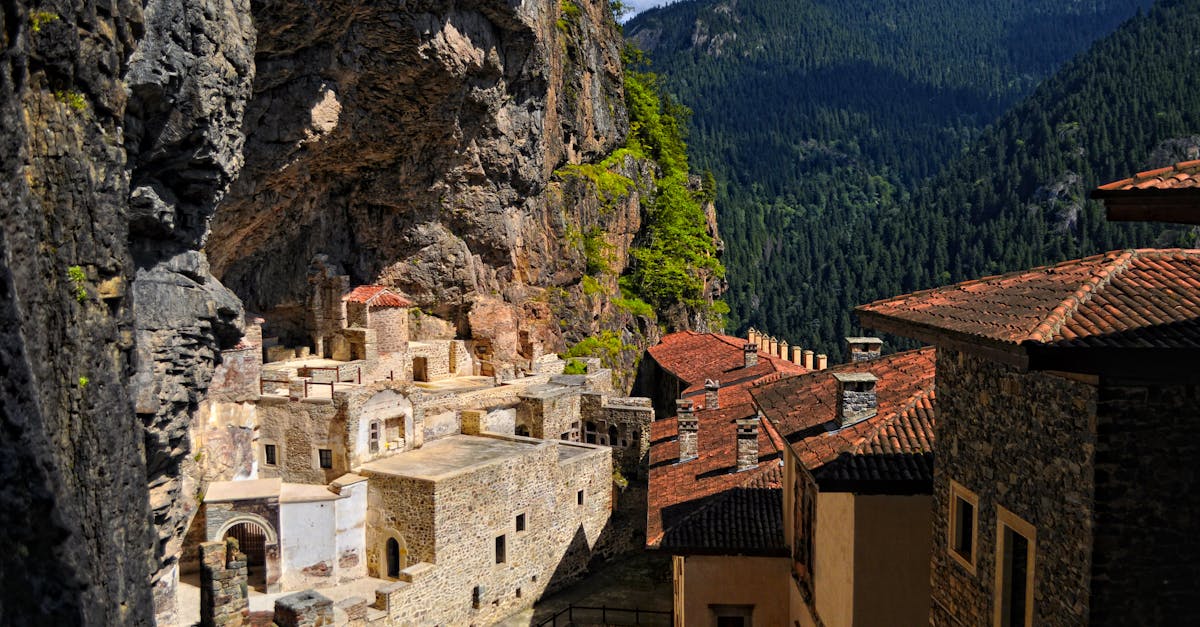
[849,495,932,627]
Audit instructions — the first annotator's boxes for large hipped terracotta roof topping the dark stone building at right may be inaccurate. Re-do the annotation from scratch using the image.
[856,249,1200,348]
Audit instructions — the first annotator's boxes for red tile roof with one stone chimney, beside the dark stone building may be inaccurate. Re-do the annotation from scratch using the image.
[751,347,936,490]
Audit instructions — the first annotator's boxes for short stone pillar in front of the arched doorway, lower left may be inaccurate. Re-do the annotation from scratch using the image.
[200,538,250,627]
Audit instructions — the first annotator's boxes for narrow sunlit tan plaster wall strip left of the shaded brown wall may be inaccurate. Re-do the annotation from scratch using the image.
[812,492,854,627]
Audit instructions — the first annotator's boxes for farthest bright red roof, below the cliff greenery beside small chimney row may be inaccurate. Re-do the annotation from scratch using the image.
[648,332,808,404]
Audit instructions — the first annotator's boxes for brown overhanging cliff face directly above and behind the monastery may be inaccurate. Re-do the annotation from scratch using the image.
[206,0,710,369]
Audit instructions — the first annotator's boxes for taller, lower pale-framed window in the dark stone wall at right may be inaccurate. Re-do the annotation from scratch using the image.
[994,507,1037,627]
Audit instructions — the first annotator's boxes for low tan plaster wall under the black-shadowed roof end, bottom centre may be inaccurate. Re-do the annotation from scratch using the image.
[683,555,791,627]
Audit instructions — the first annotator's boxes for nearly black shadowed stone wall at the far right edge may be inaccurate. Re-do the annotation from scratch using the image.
[1094,381,1200,626]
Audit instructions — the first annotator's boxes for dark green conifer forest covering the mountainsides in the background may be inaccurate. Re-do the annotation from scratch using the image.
[626,0,1200,359]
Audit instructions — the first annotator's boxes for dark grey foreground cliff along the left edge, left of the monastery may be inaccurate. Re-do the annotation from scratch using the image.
[0,0,254,625]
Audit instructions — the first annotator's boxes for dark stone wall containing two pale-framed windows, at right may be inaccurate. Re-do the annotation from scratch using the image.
[931,348,1097,627]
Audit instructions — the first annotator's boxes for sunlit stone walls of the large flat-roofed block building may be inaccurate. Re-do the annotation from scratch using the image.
[352,438,612,625]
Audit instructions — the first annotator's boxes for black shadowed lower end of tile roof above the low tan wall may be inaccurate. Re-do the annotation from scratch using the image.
[659,465,786,555]
